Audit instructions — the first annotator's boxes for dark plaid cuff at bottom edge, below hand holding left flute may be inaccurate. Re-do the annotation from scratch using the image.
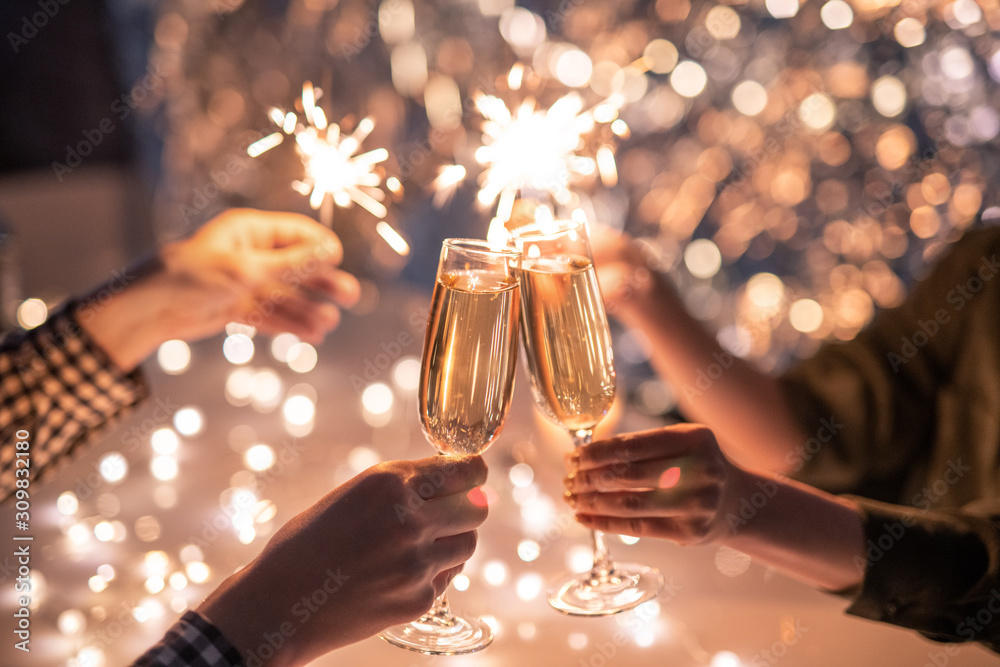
[132,611,246,667]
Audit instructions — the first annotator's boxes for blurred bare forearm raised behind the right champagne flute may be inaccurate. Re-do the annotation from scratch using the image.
[615,276,806,472]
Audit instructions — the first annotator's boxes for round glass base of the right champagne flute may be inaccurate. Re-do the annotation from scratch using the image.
[548,563,663,616]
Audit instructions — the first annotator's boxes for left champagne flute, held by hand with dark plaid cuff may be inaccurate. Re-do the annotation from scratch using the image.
[381,239,521,655]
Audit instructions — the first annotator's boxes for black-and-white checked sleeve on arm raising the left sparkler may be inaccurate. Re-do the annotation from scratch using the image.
[0,302,149,502]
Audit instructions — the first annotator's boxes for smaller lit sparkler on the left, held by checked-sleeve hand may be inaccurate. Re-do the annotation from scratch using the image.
[247,81,410,255]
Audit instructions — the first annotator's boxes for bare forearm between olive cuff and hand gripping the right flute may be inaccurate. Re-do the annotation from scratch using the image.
[719,473,865,591]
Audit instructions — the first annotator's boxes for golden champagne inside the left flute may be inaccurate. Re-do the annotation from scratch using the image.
[420,270,520,455]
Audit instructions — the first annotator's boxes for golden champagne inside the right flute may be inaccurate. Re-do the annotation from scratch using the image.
[521,255,615,431]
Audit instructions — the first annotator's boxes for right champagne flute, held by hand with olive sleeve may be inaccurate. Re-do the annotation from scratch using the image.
[513,220,663,616]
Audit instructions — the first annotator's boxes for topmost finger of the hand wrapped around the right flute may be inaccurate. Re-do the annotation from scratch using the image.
[568,424,714,470]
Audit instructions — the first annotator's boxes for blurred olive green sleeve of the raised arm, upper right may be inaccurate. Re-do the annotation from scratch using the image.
[779,228,1000,501]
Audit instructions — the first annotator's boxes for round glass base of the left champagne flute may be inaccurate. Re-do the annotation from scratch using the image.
[379,613,493,655]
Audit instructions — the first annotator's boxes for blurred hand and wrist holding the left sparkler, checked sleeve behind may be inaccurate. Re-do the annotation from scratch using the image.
[76,209,359,371]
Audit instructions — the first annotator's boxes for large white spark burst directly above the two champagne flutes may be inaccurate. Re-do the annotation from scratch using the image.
[462,64,624,221]
